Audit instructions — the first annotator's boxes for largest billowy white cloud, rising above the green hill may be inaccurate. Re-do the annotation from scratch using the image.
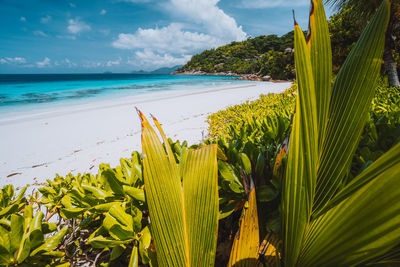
[112,0,247,67]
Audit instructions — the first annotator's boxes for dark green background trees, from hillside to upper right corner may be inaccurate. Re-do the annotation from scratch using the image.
[178,0,400,82]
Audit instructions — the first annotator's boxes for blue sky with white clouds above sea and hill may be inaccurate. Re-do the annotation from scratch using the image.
[0,0,332,74]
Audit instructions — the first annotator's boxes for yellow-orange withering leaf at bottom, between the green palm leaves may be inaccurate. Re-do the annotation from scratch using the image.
[228,187,260,267]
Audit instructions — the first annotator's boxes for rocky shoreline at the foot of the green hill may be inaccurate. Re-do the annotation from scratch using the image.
[170,70,293,83]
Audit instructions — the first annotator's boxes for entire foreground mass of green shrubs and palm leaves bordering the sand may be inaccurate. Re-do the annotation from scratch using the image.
[0,0,400,266]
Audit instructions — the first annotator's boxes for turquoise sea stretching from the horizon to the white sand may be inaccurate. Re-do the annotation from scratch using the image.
[0,73,249,116]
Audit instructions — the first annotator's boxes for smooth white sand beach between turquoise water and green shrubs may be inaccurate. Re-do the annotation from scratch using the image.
[0,82,290,186]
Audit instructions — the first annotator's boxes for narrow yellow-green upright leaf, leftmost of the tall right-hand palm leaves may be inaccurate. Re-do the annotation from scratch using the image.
[282,17,318,266]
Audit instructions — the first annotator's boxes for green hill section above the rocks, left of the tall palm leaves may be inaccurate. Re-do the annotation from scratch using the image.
[175,31,295,80]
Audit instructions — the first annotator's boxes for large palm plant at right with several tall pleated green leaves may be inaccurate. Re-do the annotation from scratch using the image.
[282,0,400,266]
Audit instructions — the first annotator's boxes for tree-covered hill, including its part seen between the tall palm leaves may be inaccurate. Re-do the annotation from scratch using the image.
[177,4,400,80]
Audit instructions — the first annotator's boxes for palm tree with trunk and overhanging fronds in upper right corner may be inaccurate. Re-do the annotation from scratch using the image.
[325,0,400,86]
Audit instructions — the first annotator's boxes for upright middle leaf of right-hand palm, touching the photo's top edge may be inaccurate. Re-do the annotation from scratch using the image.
[307,0,332,149]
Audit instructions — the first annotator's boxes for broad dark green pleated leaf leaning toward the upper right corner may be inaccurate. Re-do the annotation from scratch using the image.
[314,0,390,213]
